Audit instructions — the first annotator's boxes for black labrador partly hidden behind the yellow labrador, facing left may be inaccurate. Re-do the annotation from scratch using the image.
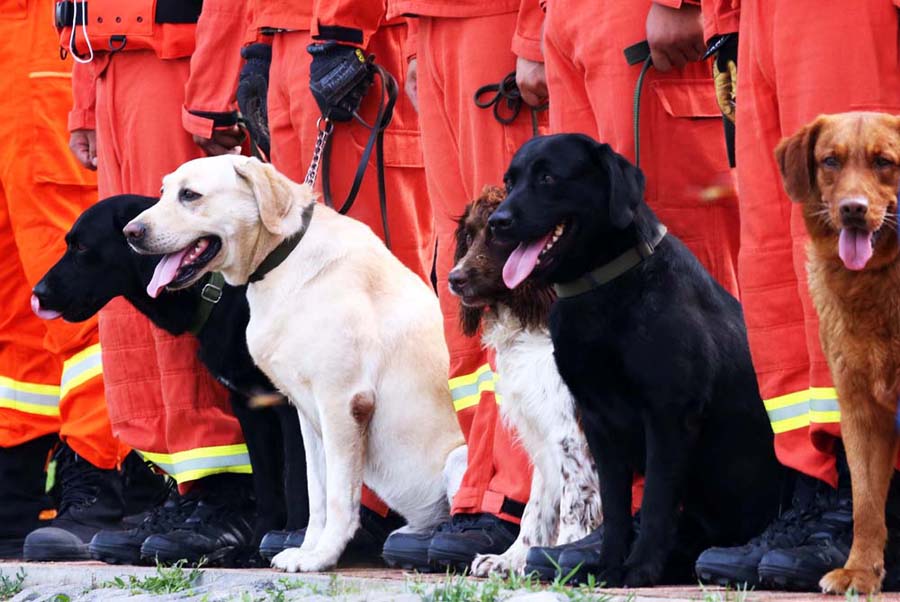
[33,195,309,542]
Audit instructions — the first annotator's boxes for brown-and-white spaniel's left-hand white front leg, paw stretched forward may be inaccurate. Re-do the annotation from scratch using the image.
[472,463,559,577]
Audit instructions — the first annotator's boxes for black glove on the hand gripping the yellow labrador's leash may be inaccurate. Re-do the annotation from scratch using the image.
[306,41,374,121]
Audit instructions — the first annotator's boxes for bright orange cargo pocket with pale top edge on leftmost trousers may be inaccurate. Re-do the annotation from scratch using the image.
[28,71,95,186]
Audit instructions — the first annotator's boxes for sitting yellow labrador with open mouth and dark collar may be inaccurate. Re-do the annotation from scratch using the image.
[124,155,465,572]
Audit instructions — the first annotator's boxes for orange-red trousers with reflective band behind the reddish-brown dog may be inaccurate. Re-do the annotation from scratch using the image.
[736,0,900,485]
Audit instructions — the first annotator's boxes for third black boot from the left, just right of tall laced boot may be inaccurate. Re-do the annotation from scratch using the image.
[90,481,197,564]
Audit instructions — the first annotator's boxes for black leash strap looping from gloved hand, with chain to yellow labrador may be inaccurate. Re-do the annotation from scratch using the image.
[318,64,398,249]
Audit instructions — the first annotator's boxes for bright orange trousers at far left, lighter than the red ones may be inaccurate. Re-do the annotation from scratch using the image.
[0,0,121,469]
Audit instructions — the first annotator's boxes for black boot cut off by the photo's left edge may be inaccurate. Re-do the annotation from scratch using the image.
[0,435,59,558]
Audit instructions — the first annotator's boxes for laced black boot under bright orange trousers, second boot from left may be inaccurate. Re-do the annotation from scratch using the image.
[24,443,125,561]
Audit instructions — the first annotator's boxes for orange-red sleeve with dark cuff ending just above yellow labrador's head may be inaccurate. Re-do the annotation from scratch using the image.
[181,0,249,138]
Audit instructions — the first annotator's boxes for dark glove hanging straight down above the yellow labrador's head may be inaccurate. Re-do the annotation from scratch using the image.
[237,44,272,156]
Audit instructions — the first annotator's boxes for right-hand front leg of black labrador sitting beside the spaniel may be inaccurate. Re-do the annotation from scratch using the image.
[624,416,694,587]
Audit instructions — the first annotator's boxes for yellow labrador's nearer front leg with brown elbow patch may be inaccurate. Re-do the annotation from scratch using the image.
[272,392,375,572]
